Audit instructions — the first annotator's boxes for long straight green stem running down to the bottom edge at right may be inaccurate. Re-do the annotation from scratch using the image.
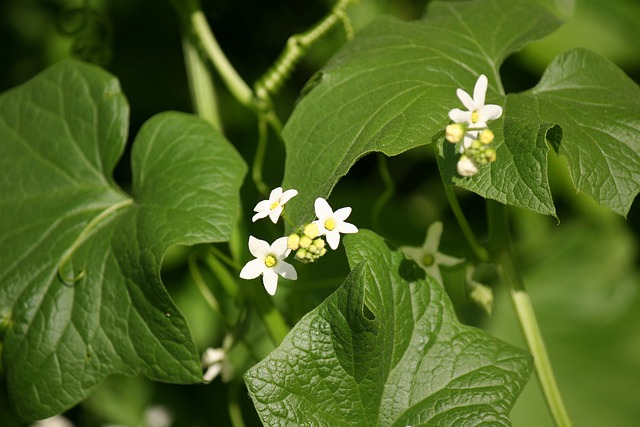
[488,200,572,427]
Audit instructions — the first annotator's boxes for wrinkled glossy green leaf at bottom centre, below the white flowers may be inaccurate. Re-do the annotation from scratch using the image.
[245,230,532,427]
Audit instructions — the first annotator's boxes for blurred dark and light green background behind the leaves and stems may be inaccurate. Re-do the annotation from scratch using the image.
[0,0,640,427]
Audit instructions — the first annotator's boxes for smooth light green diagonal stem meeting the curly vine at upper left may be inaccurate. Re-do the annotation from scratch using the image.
[189,9,254,109]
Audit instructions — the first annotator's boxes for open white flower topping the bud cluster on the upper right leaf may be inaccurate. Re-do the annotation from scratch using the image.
[449,74,502,129]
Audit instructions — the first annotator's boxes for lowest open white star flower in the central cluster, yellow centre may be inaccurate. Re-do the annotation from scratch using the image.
[240,236,298,295]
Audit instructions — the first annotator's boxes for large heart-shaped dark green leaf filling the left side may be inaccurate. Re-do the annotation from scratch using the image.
[0,61,246,419]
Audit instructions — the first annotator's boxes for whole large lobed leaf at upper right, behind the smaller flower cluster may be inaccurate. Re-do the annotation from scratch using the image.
[283,0,640,222]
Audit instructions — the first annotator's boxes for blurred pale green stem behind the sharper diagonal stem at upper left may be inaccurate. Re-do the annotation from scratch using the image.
[182,37,222,131]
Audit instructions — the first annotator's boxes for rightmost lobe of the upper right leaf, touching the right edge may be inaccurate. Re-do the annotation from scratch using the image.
[520,49,640,216]
